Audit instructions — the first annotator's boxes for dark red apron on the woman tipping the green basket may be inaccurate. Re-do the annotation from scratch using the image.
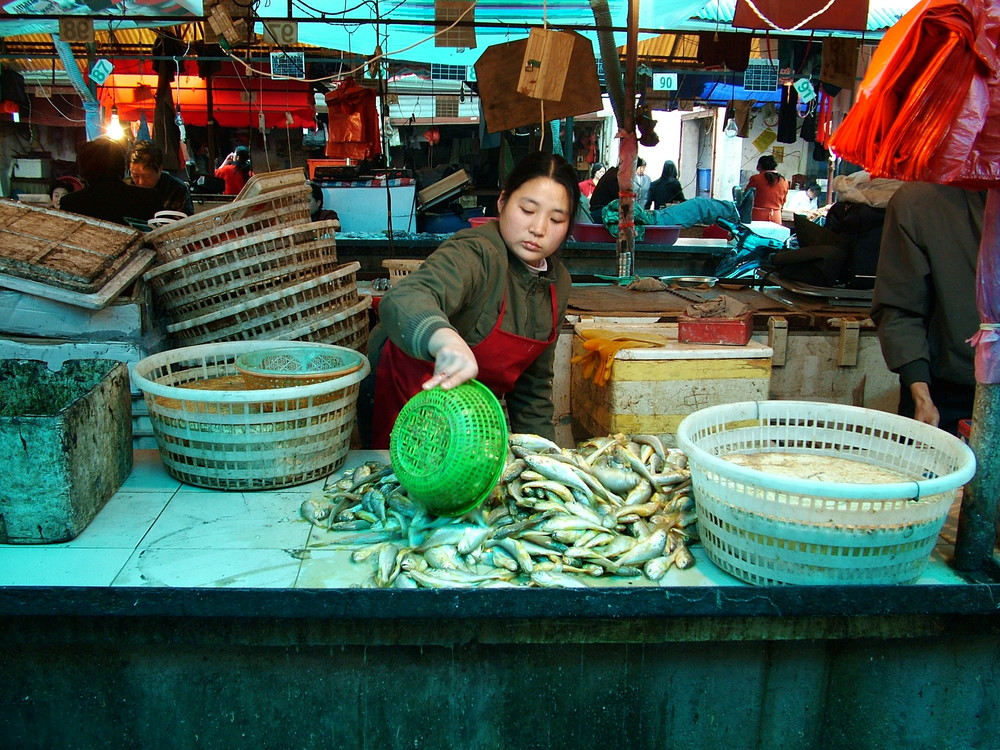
[372,284,559,449]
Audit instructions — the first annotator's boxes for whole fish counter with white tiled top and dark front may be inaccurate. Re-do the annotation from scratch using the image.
[0,451,1000,749]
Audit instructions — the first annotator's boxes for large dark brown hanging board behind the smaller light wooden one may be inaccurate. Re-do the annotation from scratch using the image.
[475,31,602,133]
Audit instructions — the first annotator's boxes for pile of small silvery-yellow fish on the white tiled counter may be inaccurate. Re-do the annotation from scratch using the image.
[300,434,698,588]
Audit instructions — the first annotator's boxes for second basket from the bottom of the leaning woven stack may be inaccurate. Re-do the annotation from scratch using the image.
[166,261,361,345]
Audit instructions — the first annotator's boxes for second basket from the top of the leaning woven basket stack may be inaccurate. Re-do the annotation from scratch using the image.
[146,184,312,263]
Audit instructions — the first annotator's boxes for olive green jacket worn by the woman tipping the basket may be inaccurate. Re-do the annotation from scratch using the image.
[368,221,570,439]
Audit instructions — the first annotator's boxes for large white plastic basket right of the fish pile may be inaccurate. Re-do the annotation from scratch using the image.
[677,401,976,584]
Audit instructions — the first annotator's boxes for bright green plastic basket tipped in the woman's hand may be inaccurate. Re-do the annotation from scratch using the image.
[389,380,507,516]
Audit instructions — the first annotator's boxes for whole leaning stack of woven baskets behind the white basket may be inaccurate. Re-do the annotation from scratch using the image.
[145,169,371,351]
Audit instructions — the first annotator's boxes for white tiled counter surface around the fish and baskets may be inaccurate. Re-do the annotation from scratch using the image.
[0,450,963,589]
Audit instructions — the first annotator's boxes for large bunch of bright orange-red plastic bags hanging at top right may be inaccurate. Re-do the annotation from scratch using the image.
[830,0,1000,187]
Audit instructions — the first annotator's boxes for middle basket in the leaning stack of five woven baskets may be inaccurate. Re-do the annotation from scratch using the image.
[145,221,337,322]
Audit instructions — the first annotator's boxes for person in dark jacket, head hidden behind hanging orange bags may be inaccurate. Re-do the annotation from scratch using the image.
[871,183,986,434]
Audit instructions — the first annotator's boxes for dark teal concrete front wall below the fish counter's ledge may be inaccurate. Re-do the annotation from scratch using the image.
[0,612,1000,750]
